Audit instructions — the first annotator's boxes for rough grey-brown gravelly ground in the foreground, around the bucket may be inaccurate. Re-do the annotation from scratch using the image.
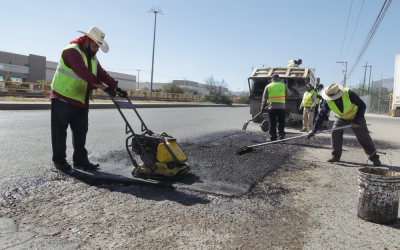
[0,121,400,250]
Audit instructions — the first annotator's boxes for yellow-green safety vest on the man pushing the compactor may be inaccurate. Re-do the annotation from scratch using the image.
[51,43,98,104]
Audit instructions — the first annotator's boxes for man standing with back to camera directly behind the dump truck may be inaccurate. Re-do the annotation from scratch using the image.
[261,74,290,141]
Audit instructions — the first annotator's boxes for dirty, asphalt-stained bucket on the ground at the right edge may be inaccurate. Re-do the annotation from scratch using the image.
[357,168,400,224]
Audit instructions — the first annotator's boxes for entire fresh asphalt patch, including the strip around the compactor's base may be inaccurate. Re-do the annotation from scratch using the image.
[60,131,391,196]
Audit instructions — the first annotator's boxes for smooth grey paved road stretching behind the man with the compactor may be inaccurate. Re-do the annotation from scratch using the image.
[0,107,253,190]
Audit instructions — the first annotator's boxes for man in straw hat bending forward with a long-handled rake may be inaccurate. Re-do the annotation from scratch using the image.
[308,83,381,166]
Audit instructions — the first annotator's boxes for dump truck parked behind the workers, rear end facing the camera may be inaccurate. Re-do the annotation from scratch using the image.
[248,67,319,123]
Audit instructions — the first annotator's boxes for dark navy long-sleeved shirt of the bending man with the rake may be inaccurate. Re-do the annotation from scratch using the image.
[312,90,367,132]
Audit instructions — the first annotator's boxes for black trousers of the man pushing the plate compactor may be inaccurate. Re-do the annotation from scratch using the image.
[51,98,89,164]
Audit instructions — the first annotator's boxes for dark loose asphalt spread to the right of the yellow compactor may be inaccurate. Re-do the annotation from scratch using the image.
[181,133,302,194]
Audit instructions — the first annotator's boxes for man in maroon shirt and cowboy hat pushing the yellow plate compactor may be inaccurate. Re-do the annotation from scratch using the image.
[50,27,127,170]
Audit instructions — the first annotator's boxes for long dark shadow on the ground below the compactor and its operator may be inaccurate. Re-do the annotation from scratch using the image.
[64,170,210,206]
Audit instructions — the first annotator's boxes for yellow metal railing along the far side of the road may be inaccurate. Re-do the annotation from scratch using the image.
[0,81,202,102]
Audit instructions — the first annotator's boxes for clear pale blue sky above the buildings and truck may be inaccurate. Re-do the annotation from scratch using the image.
[0,0,400,91]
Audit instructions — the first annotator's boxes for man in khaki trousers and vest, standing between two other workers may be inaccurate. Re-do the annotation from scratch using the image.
[299,83,317,132]
